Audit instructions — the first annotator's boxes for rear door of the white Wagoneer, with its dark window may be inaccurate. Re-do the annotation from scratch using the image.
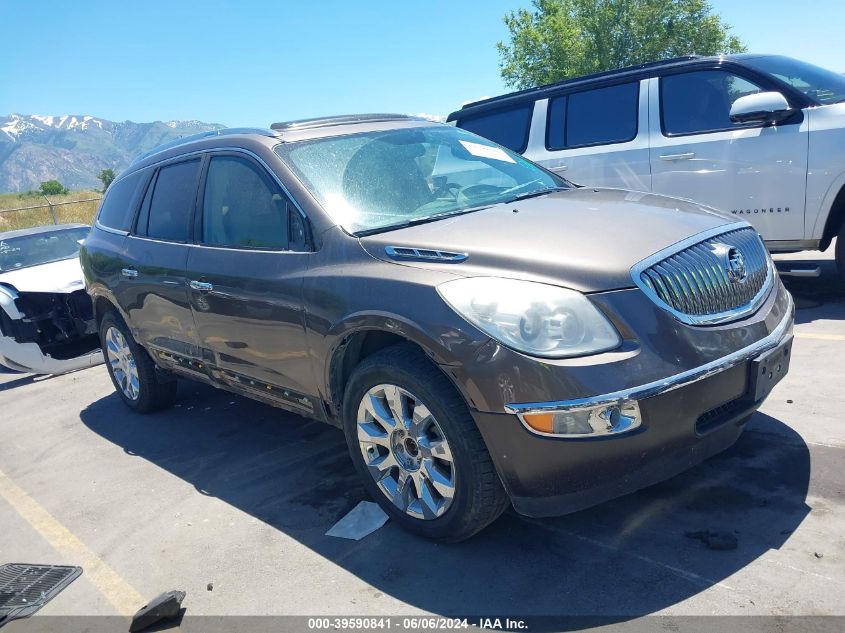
[525,81,651,191]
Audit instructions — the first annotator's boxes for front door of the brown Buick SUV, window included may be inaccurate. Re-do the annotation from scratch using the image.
[187,152,313,409]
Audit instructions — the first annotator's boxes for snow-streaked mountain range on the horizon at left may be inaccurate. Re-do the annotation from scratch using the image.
[0,114,224,192]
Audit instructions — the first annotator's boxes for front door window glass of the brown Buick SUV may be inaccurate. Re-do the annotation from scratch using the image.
[202,156,290,250]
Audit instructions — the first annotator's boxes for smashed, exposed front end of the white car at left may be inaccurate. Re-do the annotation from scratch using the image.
[0,284,103,374]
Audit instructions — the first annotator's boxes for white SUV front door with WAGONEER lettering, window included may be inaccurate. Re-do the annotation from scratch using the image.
[649,69,808,241]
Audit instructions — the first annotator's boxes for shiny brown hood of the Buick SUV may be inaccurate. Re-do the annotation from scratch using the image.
[361,188,736,292]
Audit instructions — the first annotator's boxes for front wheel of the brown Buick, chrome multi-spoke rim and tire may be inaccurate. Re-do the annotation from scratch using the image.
[343,344,510,542]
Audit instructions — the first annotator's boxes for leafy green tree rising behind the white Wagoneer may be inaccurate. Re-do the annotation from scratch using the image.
[497,0,745,88]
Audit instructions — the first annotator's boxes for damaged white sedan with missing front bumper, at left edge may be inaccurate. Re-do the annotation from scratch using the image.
[0,224,103,374]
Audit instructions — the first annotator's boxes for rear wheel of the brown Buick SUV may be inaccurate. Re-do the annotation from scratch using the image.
[100,312,176,413]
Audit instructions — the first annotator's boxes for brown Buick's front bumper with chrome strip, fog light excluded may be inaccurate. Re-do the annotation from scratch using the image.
[473,295,794,517]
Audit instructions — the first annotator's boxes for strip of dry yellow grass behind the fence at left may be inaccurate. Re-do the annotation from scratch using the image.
[0,189,102,231]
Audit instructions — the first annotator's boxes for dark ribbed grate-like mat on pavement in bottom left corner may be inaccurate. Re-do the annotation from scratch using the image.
[0,563,82,626]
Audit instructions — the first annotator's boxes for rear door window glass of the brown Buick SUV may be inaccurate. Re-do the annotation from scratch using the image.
[143,159,200,242]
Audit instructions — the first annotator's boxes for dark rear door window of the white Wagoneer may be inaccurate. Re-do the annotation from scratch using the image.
[547,82,640,149]
